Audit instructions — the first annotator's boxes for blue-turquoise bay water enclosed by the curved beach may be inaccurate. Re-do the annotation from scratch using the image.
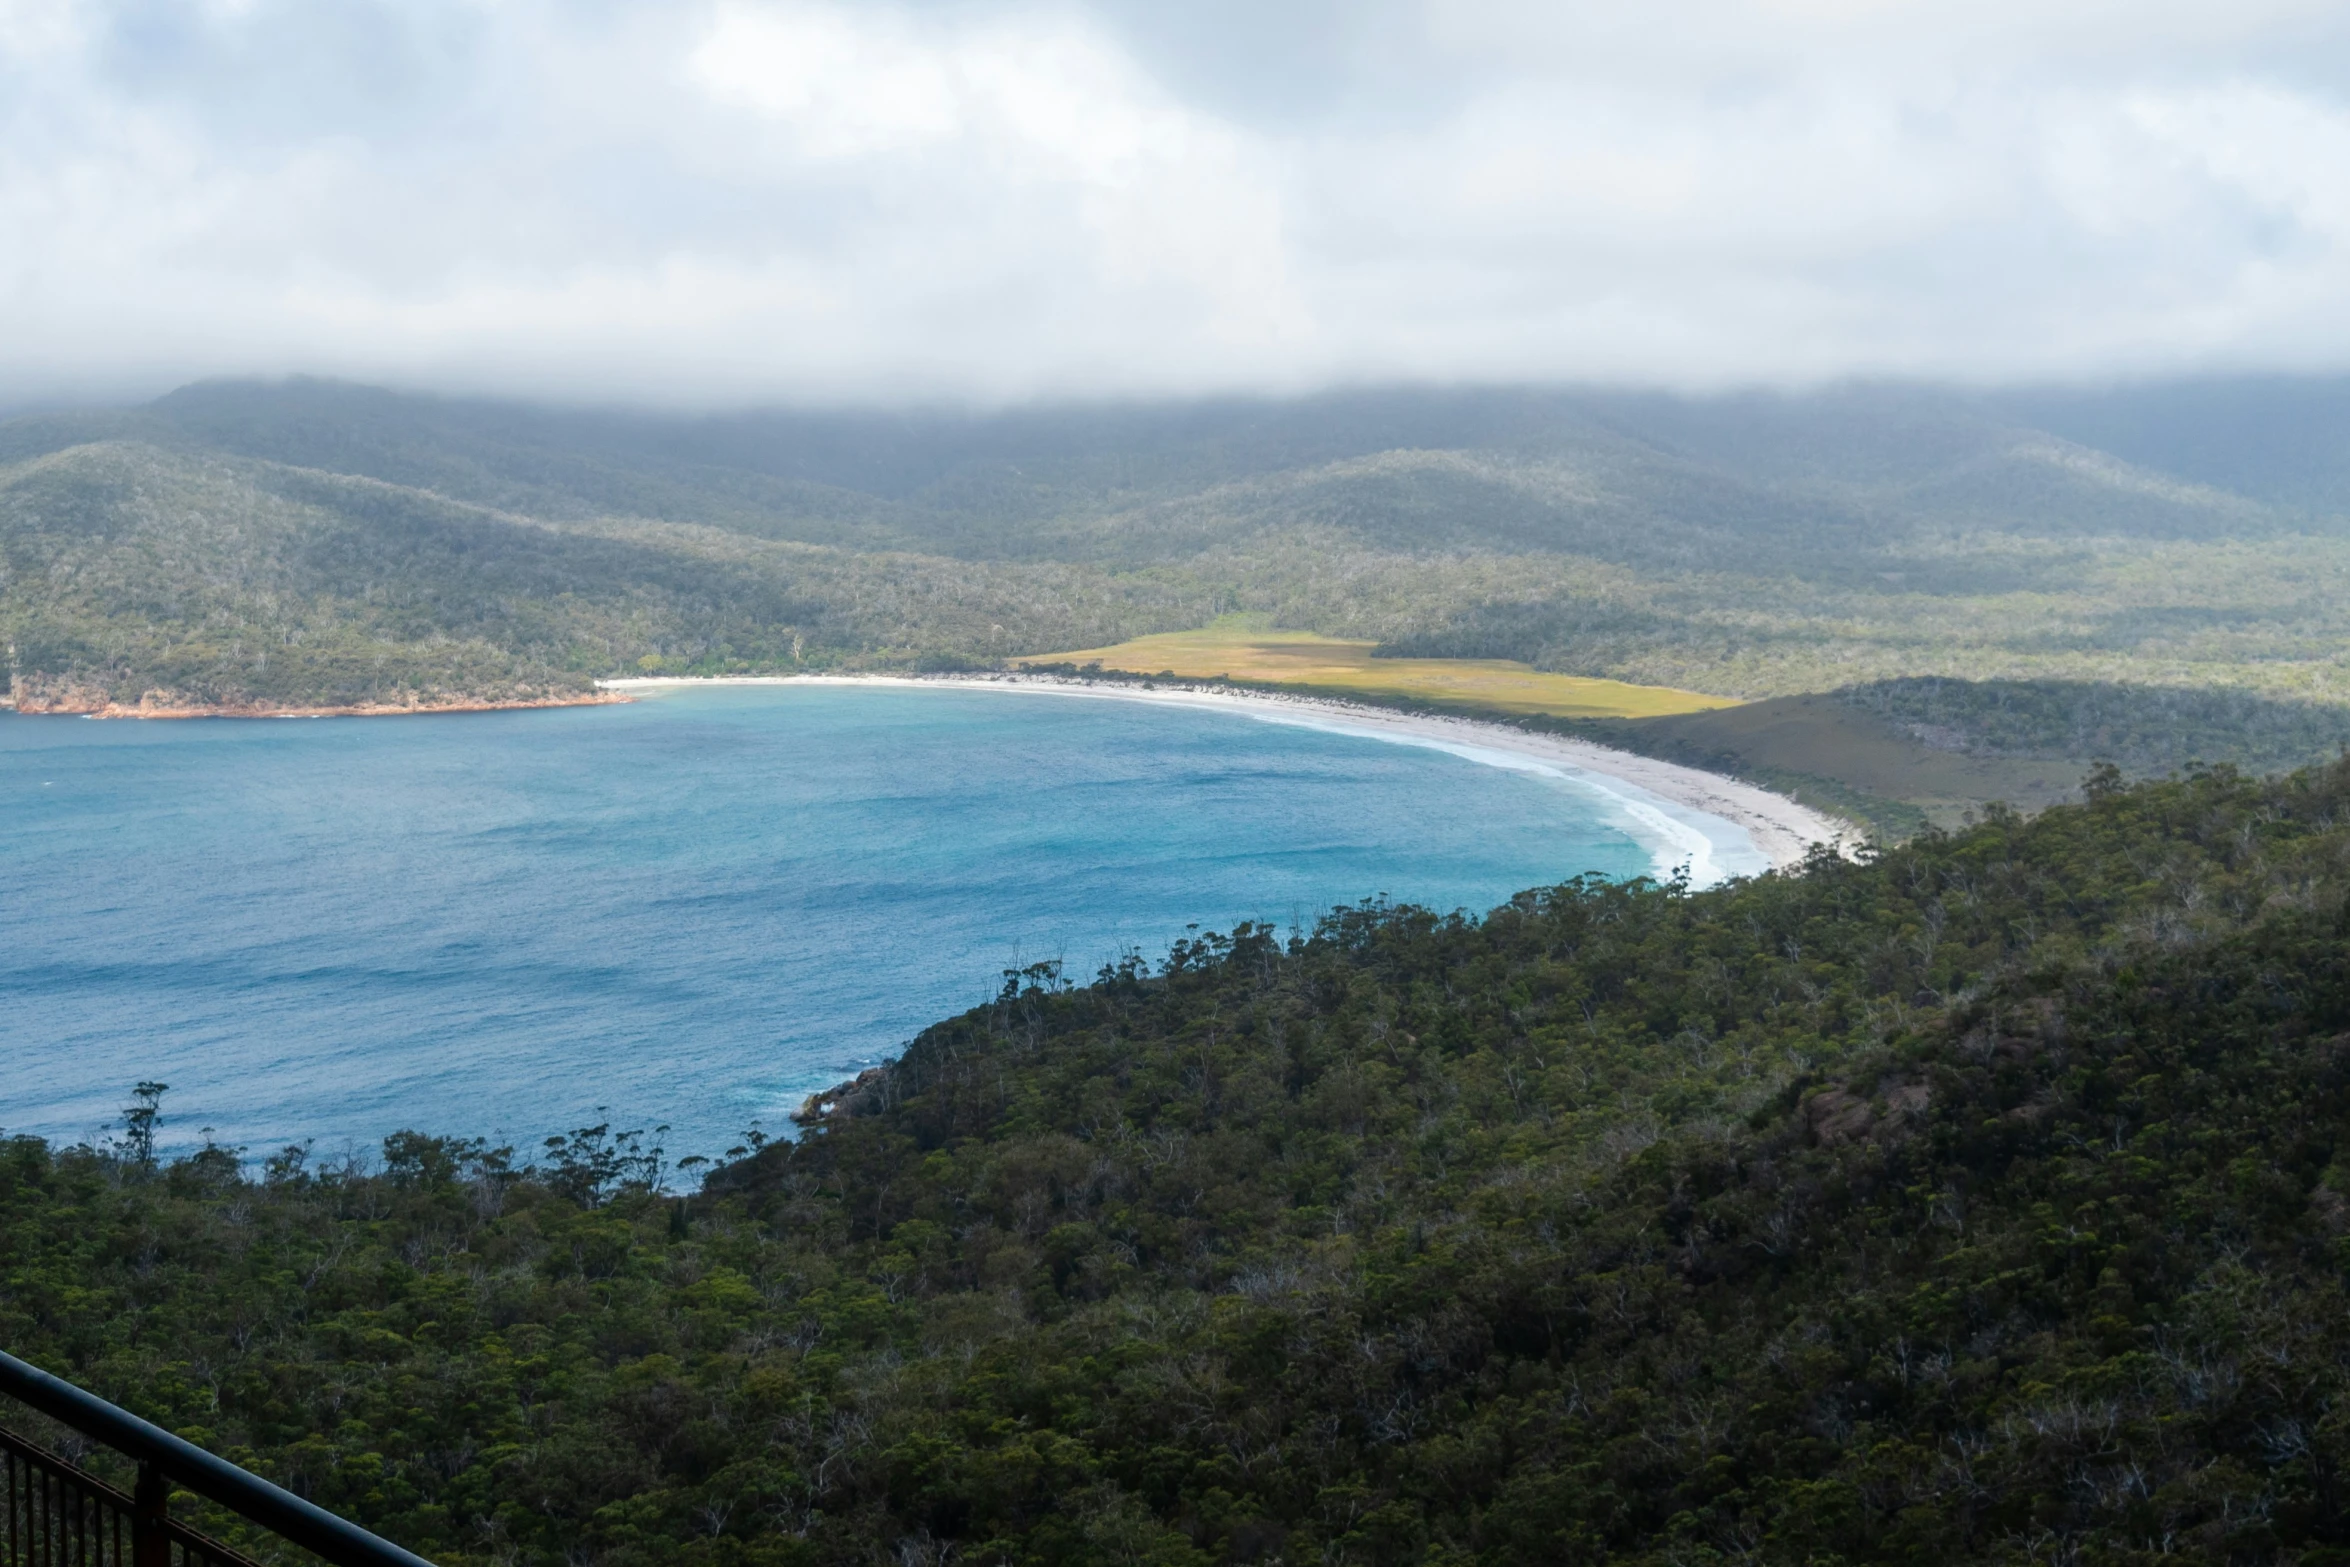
[0,686,1729,1154]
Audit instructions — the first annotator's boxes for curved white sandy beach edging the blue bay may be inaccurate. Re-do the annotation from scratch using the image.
[597,674,1861,881]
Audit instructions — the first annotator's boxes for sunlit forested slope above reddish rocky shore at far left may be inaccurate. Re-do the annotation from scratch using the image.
[0,442,1210,707]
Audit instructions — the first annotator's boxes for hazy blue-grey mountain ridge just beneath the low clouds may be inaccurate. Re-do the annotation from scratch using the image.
[13,381,2350,557]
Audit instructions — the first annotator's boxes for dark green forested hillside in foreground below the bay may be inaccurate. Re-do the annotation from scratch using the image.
[13,764,2350,1567]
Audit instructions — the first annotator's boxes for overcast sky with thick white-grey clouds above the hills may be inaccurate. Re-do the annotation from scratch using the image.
[0,0,2350,404]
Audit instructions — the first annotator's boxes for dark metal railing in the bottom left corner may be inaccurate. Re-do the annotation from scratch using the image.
[0,1351,432,1567]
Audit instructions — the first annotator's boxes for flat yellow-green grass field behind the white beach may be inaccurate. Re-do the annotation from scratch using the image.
[1013,616,1737,719]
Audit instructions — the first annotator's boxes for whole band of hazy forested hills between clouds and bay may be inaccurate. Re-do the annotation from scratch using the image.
[13,381,2350,709]
